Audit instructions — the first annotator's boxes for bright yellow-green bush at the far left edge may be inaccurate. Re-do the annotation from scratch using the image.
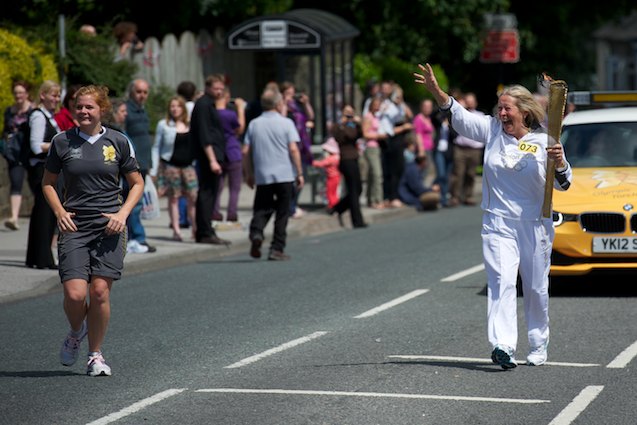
[0,29,59,128]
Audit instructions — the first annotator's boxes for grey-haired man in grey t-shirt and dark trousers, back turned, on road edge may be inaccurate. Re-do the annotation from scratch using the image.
[244,89,304,261]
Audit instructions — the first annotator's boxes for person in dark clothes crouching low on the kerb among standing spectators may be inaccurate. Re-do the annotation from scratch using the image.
[398,155,440,211]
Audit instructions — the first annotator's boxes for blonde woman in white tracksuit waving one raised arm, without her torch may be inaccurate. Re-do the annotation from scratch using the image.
[414,64,572,369]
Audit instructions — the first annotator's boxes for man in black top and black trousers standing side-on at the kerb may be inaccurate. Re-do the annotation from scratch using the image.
[190,74,230,245]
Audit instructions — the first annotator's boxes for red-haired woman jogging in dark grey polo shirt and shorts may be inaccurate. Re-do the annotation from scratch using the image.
[42,86,144,376]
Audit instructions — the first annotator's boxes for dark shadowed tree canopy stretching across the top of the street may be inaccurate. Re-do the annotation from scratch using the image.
[3,0,635,107]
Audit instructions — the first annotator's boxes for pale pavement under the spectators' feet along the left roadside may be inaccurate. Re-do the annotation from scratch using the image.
[0,181,419,303]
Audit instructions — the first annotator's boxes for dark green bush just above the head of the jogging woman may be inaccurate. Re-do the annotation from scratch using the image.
[64,28,137,96]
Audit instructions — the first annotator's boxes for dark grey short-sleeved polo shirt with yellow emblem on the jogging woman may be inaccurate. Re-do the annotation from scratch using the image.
[46,127,139,216]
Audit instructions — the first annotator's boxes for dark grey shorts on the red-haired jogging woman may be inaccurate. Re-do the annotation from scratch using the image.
[58,217,126,282]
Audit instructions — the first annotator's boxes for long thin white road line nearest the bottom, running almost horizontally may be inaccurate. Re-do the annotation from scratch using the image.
[196,388,551,404]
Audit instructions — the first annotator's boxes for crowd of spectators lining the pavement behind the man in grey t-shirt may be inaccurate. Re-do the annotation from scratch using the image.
[3,22,496,268]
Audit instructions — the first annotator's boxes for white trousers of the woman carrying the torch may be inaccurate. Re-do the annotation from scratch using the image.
[482,213,555,350]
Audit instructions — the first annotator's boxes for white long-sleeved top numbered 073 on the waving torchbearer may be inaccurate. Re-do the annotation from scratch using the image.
[451,100,573,221]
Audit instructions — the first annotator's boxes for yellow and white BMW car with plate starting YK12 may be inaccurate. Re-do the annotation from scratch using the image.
[551,107,637,276]
